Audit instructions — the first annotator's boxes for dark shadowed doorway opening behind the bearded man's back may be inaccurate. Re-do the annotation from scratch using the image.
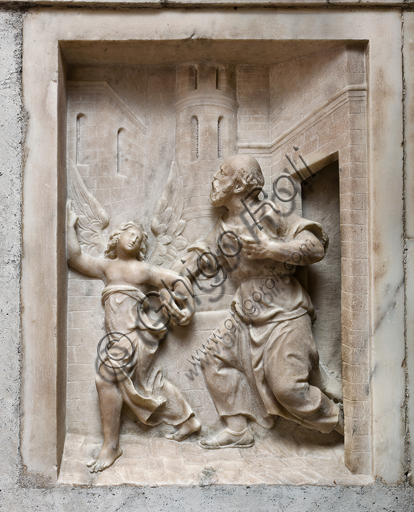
[302,162,341,377]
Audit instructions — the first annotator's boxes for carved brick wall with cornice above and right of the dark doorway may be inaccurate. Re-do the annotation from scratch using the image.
[239,47,372,473]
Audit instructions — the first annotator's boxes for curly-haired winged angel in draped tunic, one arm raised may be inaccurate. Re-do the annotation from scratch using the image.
[67,163,201,472]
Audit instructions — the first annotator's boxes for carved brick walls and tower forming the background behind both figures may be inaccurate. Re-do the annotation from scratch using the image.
[62,41,371,483]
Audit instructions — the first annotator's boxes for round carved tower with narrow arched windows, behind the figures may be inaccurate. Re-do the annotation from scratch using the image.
[175,62,238,240]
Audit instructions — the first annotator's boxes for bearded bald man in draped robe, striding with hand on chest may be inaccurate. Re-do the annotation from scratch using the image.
[173,155,344,449]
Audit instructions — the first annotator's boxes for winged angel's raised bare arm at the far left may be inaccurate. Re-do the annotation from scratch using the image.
[66,201,107,279]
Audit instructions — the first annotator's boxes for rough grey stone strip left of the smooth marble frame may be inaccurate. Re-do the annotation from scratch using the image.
[0,6,25,492]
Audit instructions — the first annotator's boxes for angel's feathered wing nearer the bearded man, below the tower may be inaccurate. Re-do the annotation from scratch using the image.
[148,162,187,267]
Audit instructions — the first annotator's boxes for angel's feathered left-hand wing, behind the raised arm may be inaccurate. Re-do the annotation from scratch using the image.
[69,162,110,256]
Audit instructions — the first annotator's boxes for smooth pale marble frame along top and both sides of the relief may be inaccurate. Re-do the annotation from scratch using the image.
[21,10,405,483]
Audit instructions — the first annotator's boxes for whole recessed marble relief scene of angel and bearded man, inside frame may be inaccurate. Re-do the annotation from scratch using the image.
[60,41,370,484]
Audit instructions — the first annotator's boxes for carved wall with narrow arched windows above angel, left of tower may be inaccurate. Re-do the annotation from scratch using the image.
[67,81,146,229]
